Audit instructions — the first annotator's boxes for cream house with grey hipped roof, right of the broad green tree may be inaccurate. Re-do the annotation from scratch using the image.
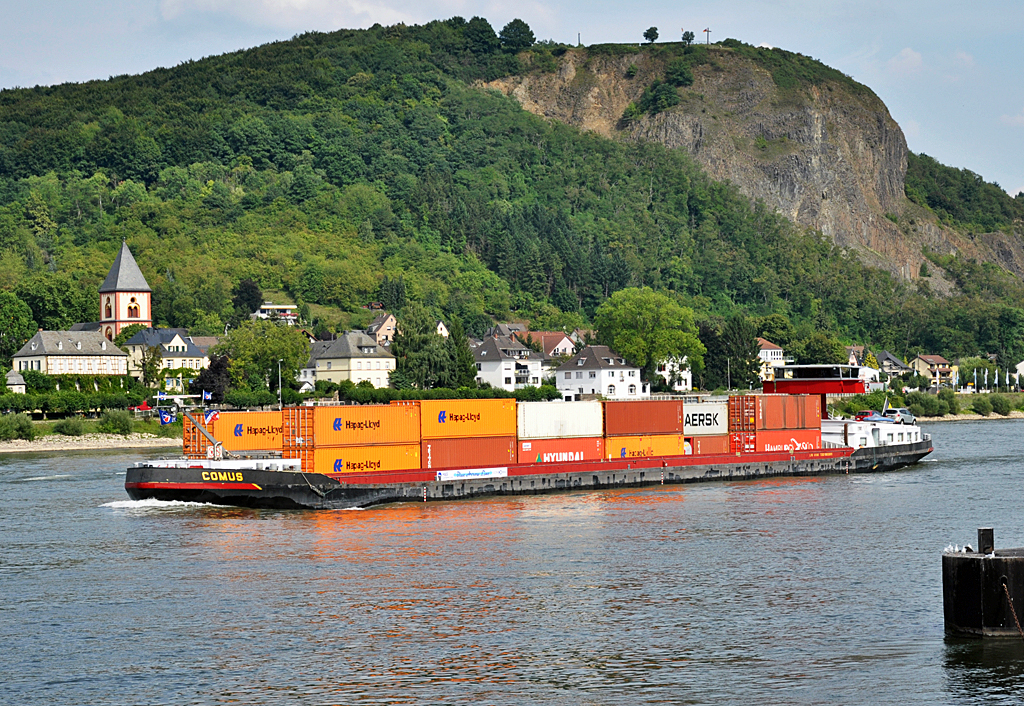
[307,331,395,387]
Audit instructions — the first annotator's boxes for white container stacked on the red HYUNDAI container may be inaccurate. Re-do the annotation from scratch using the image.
[516,402,604,463]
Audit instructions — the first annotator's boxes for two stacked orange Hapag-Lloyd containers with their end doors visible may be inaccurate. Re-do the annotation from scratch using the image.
[283,405,420,474]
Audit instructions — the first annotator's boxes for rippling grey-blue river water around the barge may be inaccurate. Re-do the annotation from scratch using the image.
[0,421,1024,705]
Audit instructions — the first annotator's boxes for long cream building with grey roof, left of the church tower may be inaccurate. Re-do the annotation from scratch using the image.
[11,331,128,375]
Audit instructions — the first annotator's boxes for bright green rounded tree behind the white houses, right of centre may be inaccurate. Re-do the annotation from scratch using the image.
[594,287,705,380]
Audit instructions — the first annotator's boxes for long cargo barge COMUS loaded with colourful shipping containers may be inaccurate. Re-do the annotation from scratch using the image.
[125,379,932,509]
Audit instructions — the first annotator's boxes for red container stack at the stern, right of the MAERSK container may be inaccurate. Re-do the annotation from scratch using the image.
[729,394,821,454]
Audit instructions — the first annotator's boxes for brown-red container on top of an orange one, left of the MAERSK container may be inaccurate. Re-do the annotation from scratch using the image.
[602,400,692,458]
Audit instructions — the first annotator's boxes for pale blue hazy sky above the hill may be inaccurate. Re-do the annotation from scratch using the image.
[0,0,1024,194]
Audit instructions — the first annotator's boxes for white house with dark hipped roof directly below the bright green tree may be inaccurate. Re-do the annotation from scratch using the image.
[555,345,650,401]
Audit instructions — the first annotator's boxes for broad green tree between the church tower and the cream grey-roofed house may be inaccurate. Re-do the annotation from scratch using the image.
[211,320,309,390]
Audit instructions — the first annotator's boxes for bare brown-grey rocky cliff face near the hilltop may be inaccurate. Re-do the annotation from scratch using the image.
[486,46,1024,282]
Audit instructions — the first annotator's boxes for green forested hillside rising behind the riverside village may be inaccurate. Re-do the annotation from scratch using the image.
[0,18,1024,360]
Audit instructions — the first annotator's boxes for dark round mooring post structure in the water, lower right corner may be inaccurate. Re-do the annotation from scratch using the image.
[942,528,1024,639]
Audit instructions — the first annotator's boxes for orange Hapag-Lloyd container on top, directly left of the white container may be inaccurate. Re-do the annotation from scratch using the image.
[420,400,516,441]
